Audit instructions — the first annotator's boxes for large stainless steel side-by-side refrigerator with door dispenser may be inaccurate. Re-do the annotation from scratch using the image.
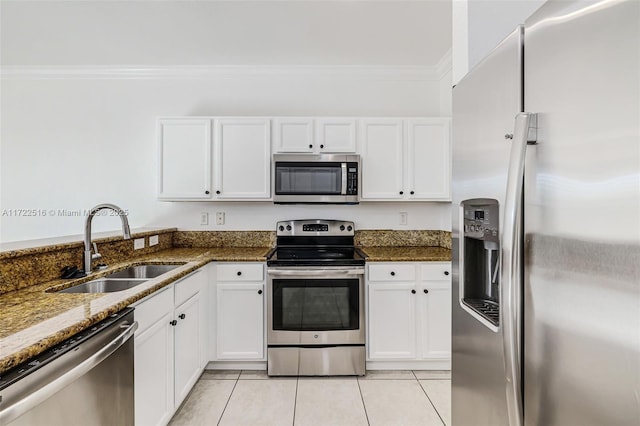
[452,0,640,426]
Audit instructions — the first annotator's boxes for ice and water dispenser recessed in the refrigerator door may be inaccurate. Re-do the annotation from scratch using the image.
[460,198,500,327]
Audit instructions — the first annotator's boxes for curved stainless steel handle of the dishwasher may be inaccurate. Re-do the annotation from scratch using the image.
[0,321,138,424]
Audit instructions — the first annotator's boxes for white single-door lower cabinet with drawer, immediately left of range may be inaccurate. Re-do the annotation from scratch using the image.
[213,262,265,361]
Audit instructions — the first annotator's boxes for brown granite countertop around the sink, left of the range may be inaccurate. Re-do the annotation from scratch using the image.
[0,247,270,373]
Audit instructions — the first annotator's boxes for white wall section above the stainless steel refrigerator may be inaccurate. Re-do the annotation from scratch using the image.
[452,0,546,84]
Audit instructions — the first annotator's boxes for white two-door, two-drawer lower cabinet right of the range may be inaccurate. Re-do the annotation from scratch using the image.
[367,262,451,369]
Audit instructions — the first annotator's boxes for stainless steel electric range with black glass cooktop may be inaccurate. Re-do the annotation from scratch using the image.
[267,219,365,376]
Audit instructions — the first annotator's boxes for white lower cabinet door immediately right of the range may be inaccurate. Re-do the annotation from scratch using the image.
[368,282,416,360]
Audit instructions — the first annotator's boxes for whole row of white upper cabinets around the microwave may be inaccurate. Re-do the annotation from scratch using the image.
[158,117,451,202]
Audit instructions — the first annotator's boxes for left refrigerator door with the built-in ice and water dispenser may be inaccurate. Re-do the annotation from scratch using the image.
[451,28,522,425]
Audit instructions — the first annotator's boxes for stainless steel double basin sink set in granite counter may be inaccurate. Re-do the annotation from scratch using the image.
[54,264,182,293]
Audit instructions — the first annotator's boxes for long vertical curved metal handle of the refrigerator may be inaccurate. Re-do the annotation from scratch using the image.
[500,112,537,426]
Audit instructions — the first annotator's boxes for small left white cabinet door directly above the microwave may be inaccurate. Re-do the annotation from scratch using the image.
[273,117,315,152]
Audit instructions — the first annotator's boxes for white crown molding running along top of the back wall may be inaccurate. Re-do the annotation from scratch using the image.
[0,64,451,81]
